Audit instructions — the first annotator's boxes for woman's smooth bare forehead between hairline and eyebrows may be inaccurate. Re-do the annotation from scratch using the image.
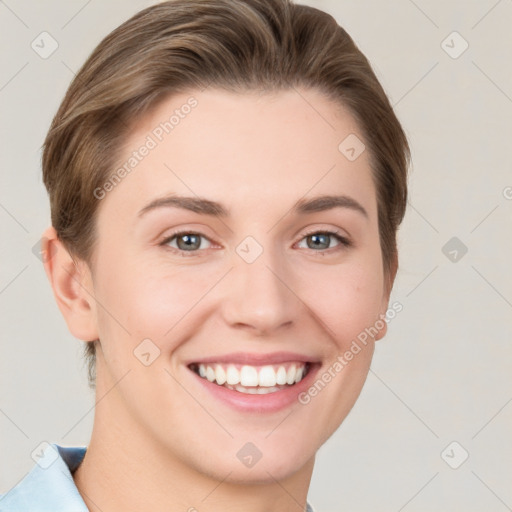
[99,89,375,222]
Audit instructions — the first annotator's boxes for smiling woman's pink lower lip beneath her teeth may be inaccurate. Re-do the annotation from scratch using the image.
[189,363,320,413]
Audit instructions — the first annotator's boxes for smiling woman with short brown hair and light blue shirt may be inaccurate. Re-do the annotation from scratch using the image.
[0,0,409,512]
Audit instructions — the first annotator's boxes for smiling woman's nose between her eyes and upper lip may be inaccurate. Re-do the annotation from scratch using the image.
[222,244,304,336]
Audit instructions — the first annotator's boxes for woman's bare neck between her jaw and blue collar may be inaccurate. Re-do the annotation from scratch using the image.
[73,372,314,512]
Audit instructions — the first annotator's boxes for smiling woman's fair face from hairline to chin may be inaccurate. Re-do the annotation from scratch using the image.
[83,89,388,482]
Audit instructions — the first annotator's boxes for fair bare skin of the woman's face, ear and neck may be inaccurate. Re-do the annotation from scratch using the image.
[44,89,396,512]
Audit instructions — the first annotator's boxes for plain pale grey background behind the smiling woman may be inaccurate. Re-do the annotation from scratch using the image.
[0,0,512,512]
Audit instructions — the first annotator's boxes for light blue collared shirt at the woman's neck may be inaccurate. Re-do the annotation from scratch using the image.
[0,443,313,512]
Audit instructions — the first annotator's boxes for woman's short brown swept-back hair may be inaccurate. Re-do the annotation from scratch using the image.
[42,0,410,387]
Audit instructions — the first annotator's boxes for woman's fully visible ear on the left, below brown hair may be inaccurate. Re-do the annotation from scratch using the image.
[41,226,98,341]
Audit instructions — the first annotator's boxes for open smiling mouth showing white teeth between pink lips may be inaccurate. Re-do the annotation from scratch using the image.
[188,361,312,395]
